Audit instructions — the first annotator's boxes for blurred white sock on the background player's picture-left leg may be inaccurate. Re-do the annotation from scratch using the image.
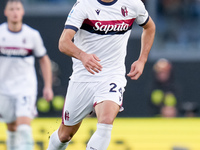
[7,131,19,150]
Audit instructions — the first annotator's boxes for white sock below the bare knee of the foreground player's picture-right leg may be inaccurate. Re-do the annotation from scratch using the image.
[86,123,113,150]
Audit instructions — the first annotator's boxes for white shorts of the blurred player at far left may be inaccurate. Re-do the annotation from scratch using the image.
[0,94,37,123]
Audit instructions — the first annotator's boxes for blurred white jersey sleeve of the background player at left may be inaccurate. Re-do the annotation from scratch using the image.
[33,31,47,57]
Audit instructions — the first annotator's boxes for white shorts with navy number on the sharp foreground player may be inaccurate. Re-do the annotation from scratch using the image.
[62,76,126,126]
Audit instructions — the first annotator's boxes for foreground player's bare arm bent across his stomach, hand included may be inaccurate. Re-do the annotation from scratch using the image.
[59,29,102,74]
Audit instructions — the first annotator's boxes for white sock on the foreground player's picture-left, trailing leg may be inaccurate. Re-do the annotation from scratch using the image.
[47,130,69,150]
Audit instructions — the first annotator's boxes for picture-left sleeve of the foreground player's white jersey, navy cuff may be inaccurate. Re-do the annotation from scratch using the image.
[65,0,87,31]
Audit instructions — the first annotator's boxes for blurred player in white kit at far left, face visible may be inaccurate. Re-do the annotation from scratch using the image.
[0,0,53,150]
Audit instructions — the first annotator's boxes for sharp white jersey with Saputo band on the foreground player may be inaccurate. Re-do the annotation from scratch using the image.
[65,0,149,82]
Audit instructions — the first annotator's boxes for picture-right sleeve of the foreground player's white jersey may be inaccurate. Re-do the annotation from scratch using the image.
[135,0,149,26]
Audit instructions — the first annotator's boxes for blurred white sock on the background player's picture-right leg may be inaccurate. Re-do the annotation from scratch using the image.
[17,124,34,150]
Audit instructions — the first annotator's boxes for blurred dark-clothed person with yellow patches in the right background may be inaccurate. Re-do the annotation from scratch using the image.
[150,58,178,117]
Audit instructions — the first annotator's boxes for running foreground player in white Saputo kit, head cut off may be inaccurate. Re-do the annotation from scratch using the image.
[48,0,155,150]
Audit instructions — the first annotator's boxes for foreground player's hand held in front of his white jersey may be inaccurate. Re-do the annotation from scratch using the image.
[80,52,102,74]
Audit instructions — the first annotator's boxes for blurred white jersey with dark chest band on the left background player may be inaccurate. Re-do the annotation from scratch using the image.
[0,23,46,96]
